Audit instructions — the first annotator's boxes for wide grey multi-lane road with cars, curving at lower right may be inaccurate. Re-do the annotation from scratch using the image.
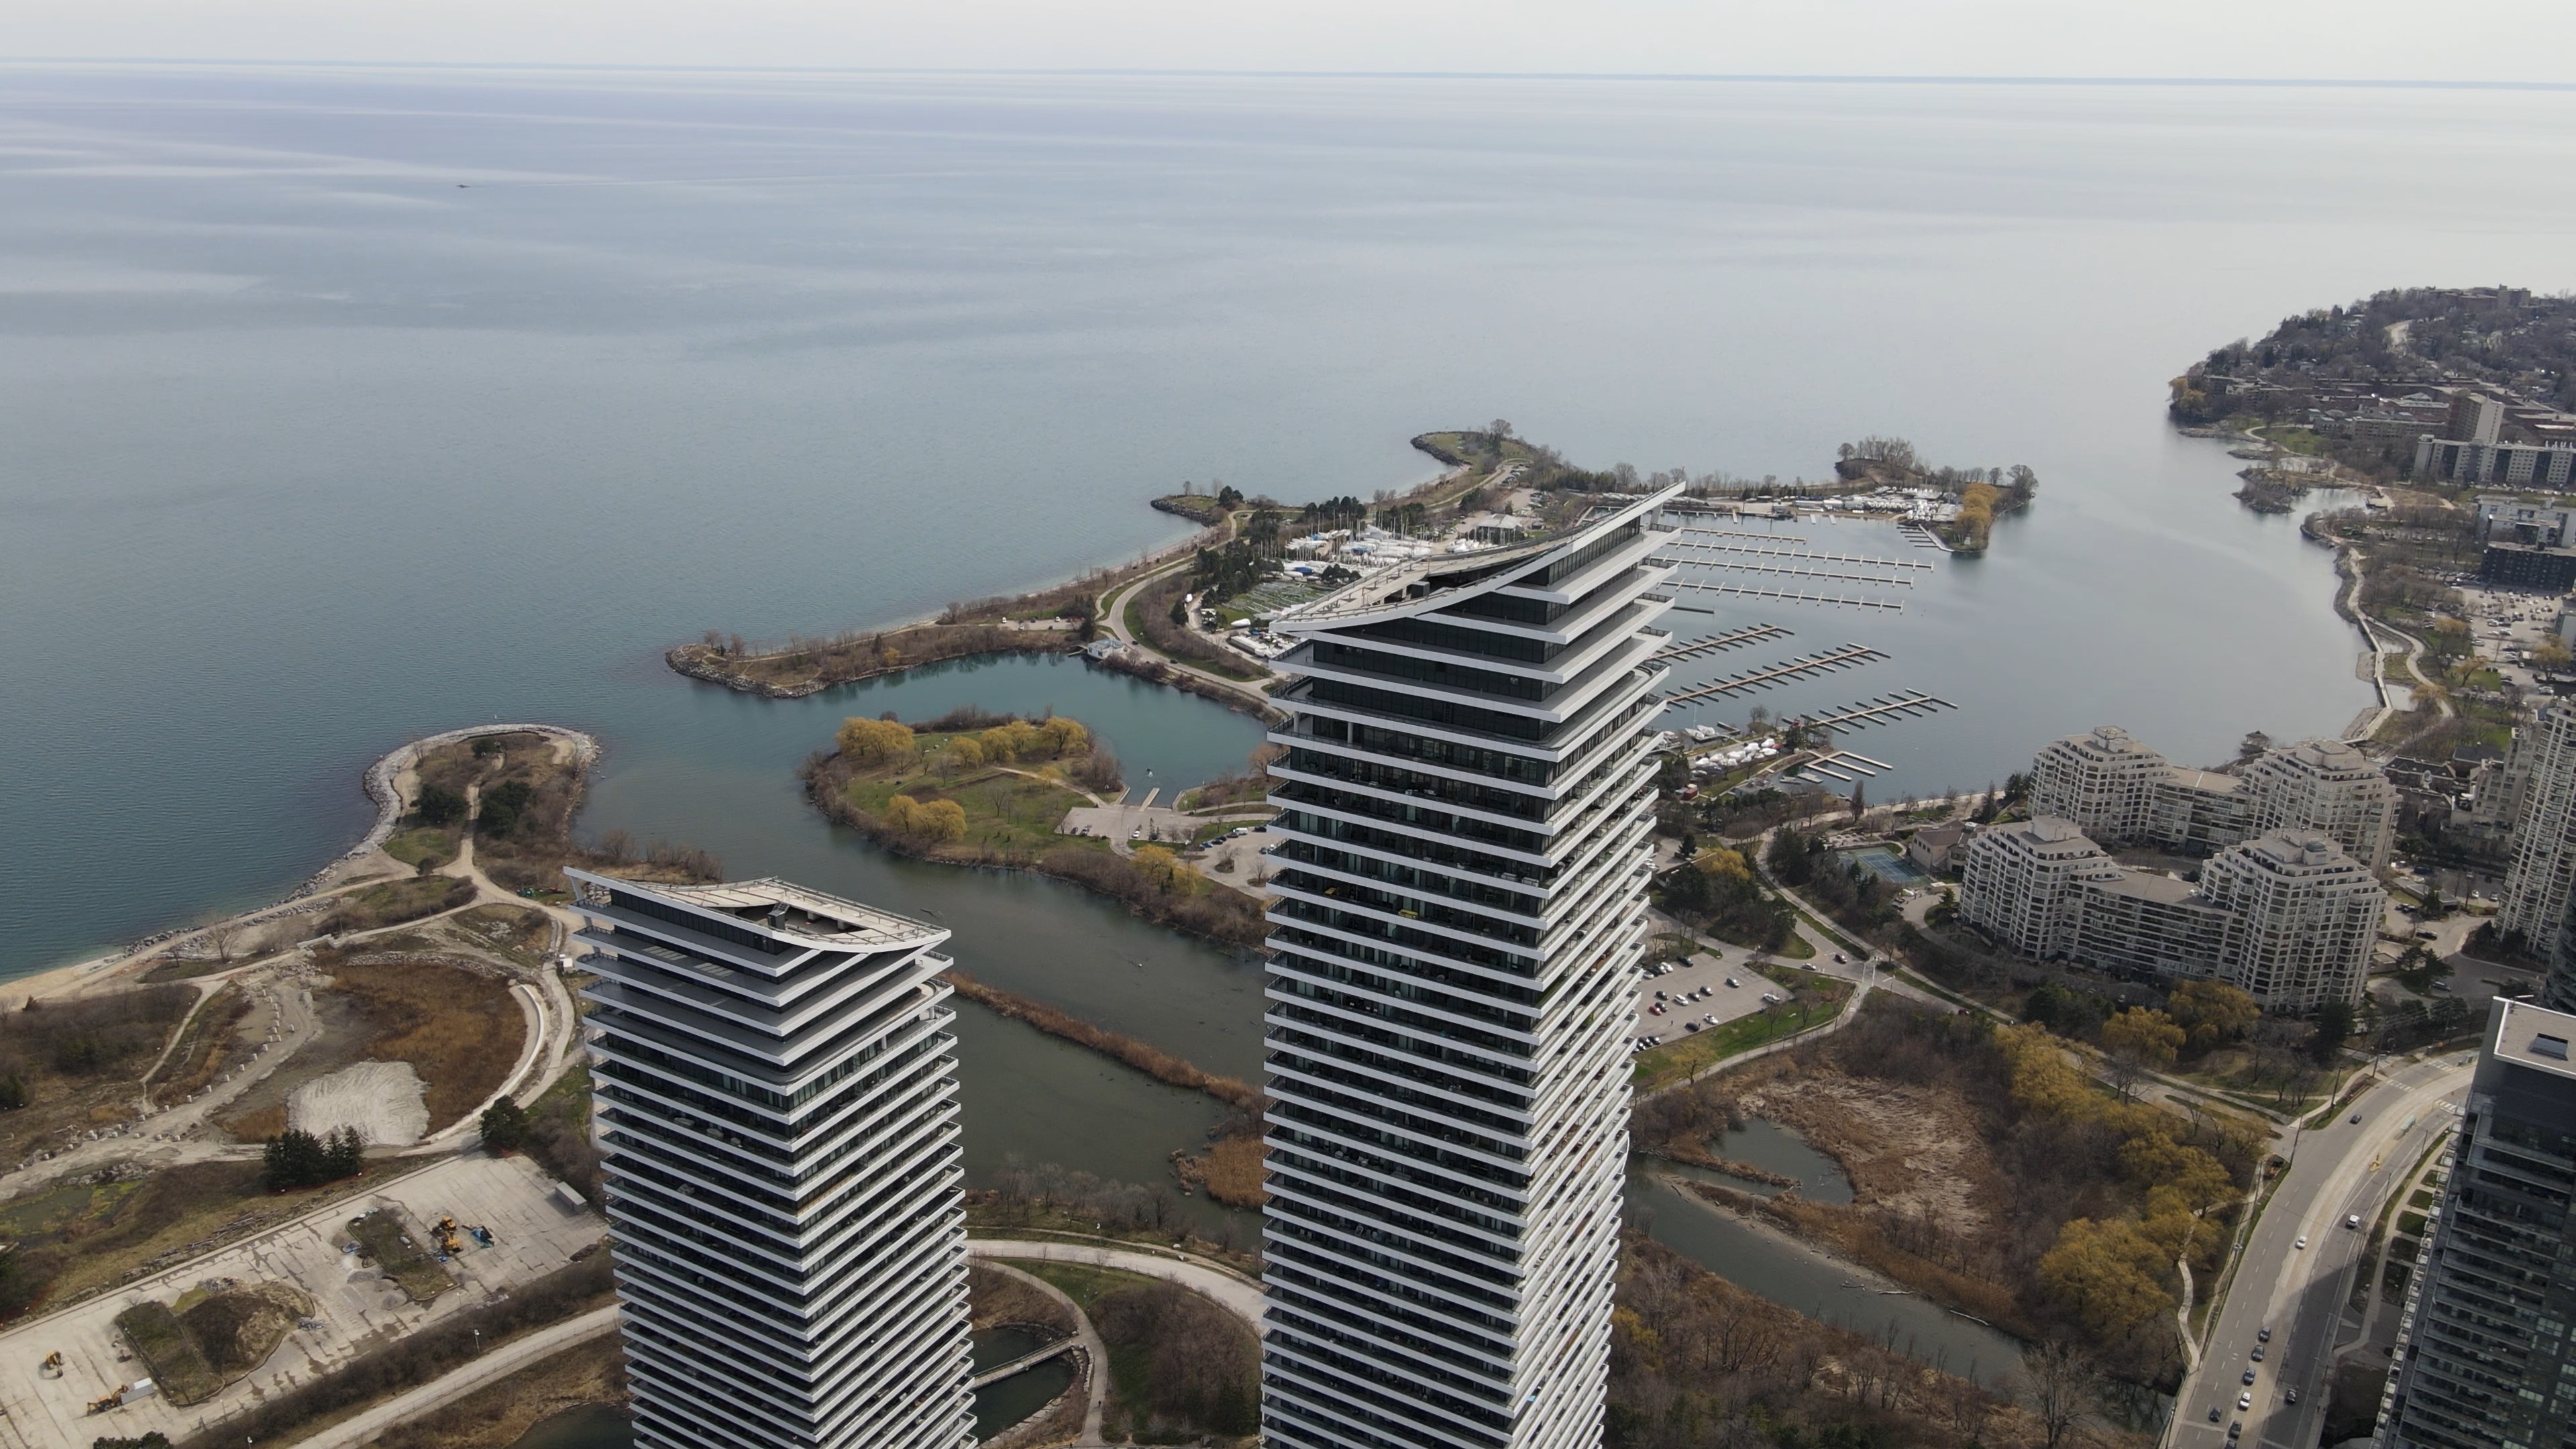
[2166,1052,2475,1449]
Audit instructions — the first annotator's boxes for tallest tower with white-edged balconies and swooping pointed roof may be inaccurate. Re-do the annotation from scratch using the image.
[1263,490,1677,1449]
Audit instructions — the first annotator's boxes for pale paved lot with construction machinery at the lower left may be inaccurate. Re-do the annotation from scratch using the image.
[0,1152,608,1449]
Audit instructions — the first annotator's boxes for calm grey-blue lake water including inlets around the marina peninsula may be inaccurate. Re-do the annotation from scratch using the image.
[0,64,2576,1340]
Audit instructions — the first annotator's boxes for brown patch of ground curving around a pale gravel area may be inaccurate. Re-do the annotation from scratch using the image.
[219,962,528,1142]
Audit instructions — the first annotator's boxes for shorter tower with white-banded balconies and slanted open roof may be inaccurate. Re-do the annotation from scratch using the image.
[564,871,974,1449]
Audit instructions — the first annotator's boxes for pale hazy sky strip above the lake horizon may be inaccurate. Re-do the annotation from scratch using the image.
[15,0,2576,83]
